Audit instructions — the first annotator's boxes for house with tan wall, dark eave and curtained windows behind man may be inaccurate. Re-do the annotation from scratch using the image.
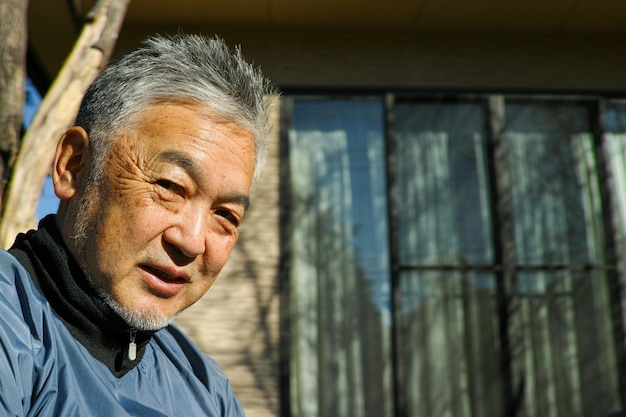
[29,0,626,417]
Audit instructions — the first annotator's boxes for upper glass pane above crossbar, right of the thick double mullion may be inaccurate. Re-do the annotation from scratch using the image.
[506,102,603,265]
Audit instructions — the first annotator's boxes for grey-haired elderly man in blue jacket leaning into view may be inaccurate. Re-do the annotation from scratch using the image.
[0,35,275,417]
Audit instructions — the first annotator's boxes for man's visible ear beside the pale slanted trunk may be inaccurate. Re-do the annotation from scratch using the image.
[52,126,89,200]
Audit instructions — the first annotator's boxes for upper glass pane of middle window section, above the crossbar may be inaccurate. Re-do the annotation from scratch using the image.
[394,102,493,265]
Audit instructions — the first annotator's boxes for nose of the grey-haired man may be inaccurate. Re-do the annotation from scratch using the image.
[163,207,207,258]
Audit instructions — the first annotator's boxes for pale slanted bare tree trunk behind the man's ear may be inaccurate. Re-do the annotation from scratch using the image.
[0,0,130,248]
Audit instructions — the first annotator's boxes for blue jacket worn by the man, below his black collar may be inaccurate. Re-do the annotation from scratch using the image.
[0,251,243,417]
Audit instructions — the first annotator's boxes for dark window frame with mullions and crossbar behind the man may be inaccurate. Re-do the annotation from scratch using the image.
[279,92,626,417]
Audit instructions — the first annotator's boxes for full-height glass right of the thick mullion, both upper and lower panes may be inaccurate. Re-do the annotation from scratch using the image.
[506,101,619,417]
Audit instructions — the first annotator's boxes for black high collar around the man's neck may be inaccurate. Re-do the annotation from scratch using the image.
[9,215,153,378]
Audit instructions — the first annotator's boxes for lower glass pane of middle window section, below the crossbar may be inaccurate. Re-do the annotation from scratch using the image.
[397,272,503,417]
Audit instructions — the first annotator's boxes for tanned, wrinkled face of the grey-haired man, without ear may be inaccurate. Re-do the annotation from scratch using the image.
[61,104,254,327]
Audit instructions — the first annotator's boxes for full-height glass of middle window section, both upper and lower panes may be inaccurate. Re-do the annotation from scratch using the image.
[394,101,502,416]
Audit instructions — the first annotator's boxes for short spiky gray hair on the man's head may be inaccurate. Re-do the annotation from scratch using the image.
[76,34,277,182]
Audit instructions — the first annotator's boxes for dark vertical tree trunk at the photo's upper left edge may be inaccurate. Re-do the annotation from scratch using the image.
[0,0,28,201]
